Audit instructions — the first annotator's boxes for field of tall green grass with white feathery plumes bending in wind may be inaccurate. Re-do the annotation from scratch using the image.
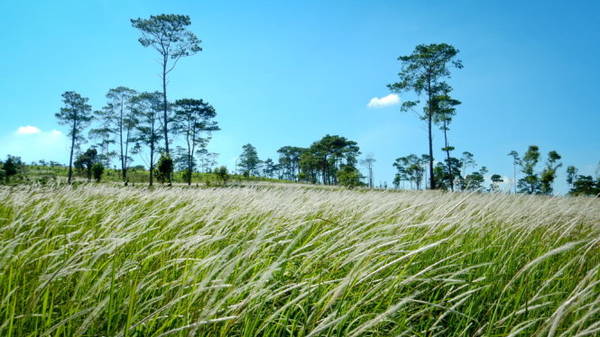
[0,185,600,337]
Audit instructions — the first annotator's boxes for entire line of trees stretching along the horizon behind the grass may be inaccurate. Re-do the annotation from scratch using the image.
[0,14,600,195]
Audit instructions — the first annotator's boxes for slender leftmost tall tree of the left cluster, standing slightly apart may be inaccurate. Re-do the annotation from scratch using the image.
[55,91,93,184]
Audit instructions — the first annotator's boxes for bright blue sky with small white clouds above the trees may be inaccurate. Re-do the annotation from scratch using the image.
[0,0,600,192]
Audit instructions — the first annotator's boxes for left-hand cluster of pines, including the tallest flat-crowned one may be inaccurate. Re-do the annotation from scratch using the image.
[55,14,219,186]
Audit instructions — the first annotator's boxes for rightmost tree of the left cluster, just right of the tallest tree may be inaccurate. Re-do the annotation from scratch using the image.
[175,99,220,185]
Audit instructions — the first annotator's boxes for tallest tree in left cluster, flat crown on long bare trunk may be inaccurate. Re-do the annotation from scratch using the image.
[131,14,202,155]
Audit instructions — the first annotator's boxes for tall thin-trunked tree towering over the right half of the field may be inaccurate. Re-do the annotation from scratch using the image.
[388,43,463,189]
